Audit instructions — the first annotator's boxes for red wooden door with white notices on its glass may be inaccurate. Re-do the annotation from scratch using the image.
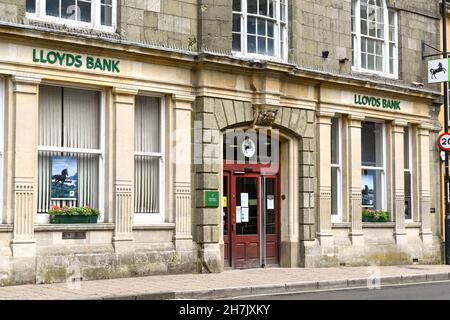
[231,174,260,268]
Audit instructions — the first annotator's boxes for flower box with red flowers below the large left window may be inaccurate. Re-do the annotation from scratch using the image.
[48,205,99,224]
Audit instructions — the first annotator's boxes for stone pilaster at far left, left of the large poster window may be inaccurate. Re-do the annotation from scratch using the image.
[11,76,41,257]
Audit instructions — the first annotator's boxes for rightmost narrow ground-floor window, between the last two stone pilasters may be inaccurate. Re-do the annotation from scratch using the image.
[403,126,413,221]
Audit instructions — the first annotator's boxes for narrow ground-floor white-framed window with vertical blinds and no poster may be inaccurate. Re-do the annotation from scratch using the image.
[134,96,164,223]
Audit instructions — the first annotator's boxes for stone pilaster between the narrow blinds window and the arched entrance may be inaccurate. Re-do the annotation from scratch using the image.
[171,95,194,251]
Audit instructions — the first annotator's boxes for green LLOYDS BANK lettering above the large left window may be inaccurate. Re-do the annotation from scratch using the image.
[33,49,120,73]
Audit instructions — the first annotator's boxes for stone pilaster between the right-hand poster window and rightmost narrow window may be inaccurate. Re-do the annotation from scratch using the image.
[392,120,407,246]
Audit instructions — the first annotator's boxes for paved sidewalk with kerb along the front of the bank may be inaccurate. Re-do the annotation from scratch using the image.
[0,265,450,300]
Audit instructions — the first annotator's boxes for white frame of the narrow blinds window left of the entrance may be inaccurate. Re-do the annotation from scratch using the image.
[133,93,166,225]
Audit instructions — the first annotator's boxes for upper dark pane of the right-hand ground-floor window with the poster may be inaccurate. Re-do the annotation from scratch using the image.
[361,122,383,167]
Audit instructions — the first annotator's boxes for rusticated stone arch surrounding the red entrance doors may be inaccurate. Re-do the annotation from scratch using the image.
[193,97,316,272]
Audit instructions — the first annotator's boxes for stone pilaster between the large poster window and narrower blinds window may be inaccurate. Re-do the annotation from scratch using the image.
[112,88,137,253]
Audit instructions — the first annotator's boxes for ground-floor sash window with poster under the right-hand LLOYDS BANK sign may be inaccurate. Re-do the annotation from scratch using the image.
[361,121,386,210]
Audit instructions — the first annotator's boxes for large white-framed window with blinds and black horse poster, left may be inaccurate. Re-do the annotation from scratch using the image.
[37,85,104,222]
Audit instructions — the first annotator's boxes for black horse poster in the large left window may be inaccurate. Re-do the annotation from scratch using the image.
[51,157,78,200]
